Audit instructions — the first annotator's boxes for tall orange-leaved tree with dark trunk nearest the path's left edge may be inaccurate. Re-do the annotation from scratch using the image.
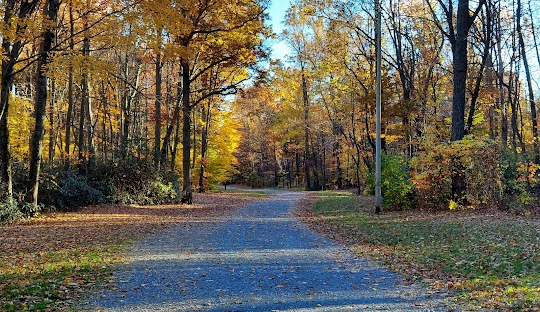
[174,0,265,204]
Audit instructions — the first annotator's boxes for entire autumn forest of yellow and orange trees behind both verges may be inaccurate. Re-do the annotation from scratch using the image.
[0,0,540,221]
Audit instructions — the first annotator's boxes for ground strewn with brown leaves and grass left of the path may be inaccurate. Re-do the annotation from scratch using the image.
[0,193,256,311]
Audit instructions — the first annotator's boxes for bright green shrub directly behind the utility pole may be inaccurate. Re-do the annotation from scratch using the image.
[367,154,416,209]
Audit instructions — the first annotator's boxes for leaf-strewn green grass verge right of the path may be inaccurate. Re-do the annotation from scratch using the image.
[298,192,540,311]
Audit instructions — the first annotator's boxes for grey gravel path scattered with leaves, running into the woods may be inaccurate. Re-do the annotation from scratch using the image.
[85,191,454,311]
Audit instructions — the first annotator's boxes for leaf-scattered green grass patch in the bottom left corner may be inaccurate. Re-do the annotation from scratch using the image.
[0,243,125,311]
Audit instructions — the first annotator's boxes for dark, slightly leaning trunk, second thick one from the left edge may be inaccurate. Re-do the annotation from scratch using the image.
[26,0,59,206]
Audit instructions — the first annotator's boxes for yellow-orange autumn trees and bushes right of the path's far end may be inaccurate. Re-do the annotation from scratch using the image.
[236,0,540,213]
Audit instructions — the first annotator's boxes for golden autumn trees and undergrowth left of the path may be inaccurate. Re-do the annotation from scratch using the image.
[0,0,270,220]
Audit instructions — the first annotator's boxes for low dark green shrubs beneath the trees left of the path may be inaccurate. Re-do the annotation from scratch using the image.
[4,159,180,213]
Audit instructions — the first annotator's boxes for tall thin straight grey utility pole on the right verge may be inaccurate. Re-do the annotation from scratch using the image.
[375,0,382,214]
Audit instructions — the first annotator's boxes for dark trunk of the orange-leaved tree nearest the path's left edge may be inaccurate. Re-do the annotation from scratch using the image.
[181,59,193,205]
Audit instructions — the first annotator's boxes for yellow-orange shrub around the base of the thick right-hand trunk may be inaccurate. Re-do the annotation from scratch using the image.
[411,136,503,209]
